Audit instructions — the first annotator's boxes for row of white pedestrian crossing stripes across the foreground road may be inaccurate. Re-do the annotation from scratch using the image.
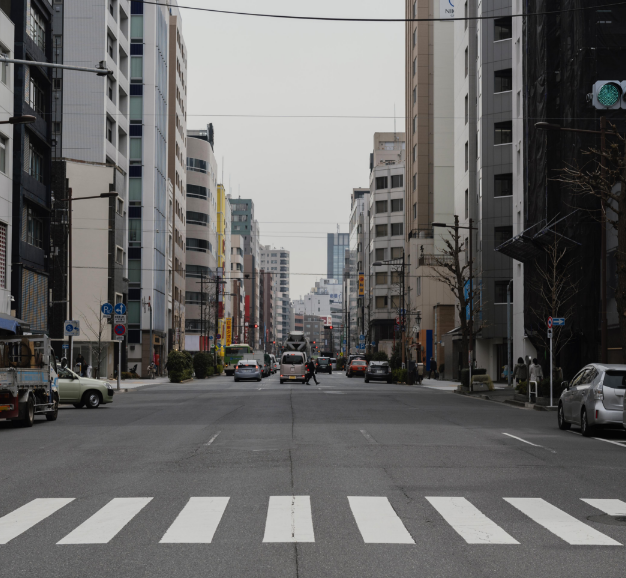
[0,496,626,546]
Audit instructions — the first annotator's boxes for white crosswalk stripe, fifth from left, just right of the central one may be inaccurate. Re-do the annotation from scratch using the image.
[348,496,415,544]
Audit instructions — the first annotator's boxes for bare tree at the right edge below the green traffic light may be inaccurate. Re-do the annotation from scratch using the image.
[556,132,626,363]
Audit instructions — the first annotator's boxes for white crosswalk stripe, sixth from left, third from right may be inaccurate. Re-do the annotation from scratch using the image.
[426,496,519,544]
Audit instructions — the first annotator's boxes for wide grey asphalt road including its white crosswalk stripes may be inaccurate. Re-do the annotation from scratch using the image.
[0,373,626,578]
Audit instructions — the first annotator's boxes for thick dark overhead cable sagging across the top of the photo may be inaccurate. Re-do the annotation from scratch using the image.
[136,0,626,23]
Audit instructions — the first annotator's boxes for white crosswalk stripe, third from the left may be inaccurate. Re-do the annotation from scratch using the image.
[161,498,230,544]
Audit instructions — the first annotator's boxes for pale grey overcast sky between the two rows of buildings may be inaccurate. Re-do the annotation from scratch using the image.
[179,0,404,299]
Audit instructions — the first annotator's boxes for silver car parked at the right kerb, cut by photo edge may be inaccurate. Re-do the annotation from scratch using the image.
[557,363,626,437]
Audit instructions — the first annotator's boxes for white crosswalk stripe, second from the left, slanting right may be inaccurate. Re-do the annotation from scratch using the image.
[57,498,152,544]
